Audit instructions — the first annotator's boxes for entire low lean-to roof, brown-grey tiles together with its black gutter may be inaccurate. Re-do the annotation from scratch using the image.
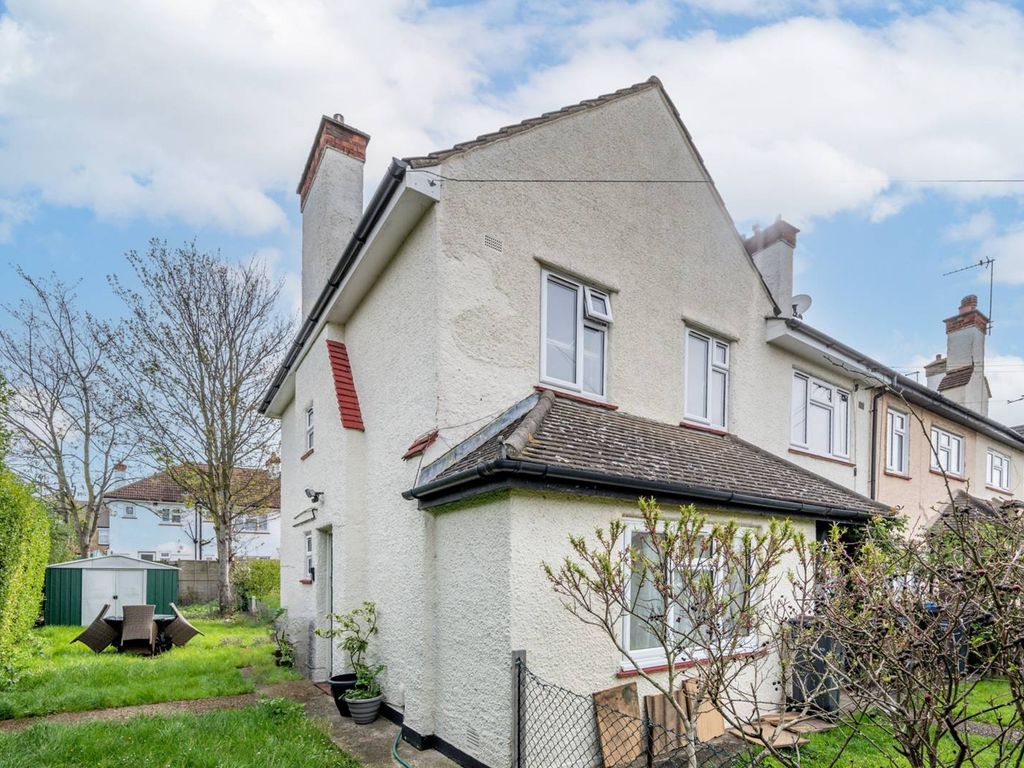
[406,391,888,518]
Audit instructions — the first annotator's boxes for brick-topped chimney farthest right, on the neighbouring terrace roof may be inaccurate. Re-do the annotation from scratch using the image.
[925,294,992,416]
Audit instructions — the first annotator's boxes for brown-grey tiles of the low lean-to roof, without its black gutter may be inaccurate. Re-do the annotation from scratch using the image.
[428,392,886,514]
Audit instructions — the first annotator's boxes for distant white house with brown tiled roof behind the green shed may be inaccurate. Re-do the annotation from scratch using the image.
[104,472,281,561]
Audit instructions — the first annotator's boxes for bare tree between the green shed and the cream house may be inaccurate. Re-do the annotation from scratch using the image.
[112,241,289,611]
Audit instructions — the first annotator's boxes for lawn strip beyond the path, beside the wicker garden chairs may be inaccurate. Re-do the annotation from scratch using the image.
[0,618,298,720]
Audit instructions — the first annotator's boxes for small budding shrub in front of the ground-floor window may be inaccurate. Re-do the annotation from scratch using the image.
[544,499,811,768]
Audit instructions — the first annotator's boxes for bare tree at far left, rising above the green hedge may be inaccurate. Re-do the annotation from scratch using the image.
[0,269,134,557]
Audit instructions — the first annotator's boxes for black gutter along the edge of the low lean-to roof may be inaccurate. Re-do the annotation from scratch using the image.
[402,459,883,522]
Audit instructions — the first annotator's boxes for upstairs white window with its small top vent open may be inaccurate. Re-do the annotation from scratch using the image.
[541,271,611,399]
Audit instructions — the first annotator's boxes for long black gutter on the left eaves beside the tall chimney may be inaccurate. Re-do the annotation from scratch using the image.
[259,158,409,414]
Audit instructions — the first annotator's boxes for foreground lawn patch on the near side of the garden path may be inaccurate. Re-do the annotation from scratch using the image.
[0,699,359,768]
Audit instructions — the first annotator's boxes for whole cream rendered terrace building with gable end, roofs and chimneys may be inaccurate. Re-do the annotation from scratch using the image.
[263,78,1024,766]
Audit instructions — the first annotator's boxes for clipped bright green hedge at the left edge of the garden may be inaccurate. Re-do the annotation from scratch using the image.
[0,467,50,688]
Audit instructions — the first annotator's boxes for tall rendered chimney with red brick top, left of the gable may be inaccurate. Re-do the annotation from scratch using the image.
[296,115,370,317]
